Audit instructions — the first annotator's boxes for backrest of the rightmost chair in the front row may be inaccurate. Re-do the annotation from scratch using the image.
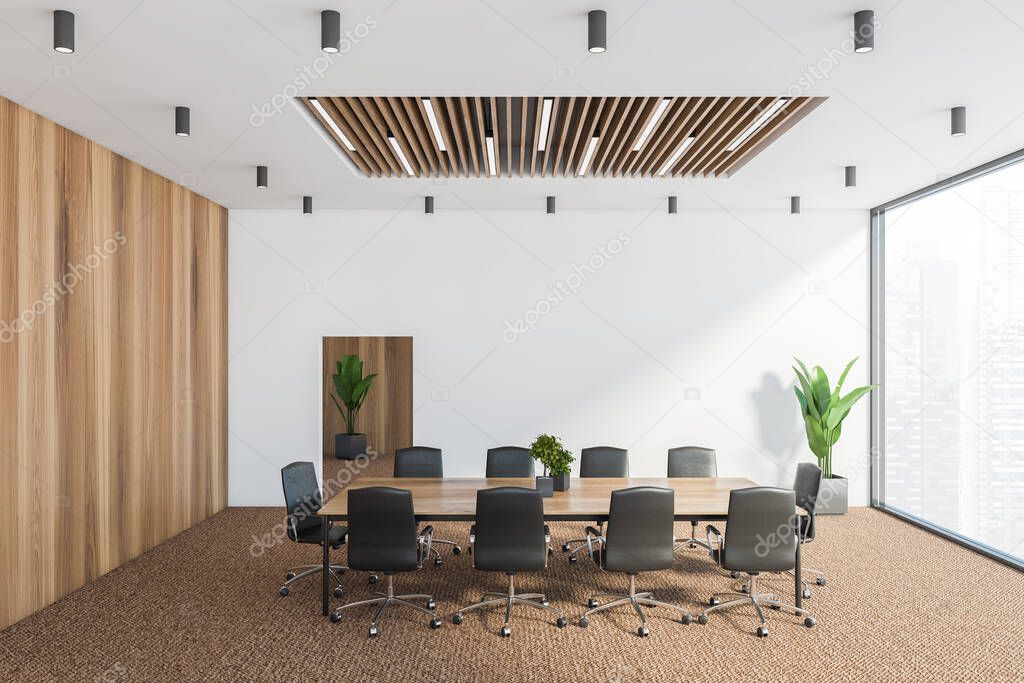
[723,486,797,571]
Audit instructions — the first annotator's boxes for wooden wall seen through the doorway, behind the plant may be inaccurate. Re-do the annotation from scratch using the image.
[323,337,413,478]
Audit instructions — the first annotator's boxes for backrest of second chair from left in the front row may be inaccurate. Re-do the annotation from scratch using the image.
[473,486,548,571]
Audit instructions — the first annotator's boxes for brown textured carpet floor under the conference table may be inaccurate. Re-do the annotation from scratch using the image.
[0,508,1024,683]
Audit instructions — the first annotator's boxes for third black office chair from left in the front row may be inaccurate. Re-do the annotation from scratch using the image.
[580,486,693,637]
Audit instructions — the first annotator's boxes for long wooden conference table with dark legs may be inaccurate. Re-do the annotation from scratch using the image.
[316,477,802,616]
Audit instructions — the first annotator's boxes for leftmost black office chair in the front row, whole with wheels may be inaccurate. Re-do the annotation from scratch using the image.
[331,486,441,637]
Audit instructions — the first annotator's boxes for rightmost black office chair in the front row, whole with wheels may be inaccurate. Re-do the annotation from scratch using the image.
[697,486,816,638]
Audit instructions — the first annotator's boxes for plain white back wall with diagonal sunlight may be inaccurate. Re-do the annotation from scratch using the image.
[228,208,868,505]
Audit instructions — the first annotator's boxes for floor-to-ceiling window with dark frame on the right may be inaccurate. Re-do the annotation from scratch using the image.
[872,152,1024,565]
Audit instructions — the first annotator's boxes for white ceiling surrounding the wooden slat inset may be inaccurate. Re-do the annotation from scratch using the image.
[0,0,1024,212]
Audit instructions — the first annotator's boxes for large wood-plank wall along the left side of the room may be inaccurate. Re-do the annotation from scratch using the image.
[0,97,227,628]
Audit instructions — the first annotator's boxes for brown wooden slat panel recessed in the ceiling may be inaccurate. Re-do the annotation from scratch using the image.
[302,95,825,178]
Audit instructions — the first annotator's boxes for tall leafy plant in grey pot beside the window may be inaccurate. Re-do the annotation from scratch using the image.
[793,358,878,515]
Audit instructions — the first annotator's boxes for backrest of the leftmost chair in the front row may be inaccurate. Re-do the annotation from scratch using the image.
[348,486,419,573]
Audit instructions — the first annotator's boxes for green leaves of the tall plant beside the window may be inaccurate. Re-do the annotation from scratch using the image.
[793,358,878,478]
